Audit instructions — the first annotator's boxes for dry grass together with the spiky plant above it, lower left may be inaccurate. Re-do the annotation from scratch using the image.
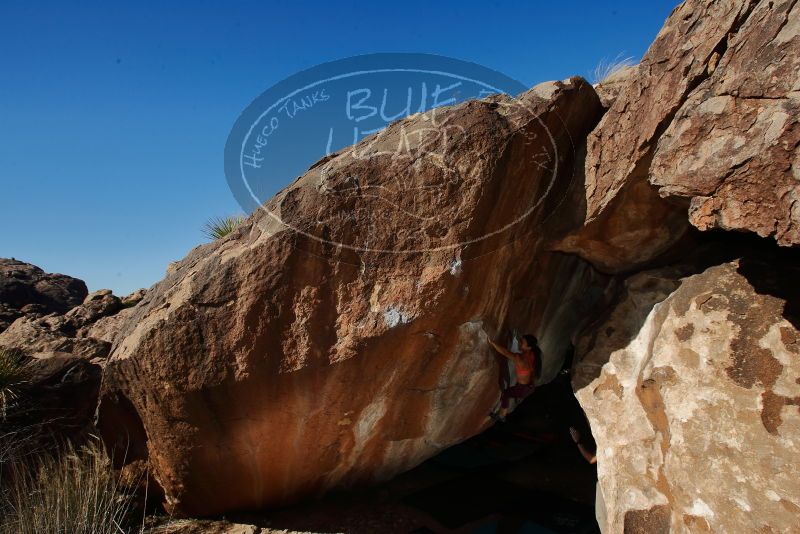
[0,348,140,534]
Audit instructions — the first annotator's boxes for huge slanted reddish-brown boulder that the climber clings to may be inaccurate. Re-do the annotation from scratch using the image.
[99,78,602,515]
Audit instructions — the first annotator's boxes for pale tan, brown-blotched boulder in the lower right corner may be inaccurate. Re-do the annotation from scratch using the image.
[577,259,800,534]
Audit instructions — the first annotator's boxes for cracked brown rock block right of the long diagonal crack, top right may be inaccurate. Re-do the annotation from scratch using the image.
[650,0,800,245]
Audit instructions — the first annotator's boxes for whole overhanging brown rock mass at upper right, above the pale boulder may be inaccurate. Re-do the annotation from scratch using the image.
[558,0,800,272]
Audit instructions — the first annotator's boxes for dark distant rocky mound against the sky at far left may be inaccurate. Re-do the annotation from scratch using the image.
[0,258,89,332]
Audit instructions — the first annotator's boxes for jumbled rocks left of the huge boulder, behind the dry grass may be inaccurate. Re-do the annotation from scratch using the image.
[0,264,144,452]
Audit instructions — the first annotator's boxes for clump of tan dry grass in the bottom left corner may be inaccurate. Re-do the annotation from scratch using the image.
[0,442,139,534]
